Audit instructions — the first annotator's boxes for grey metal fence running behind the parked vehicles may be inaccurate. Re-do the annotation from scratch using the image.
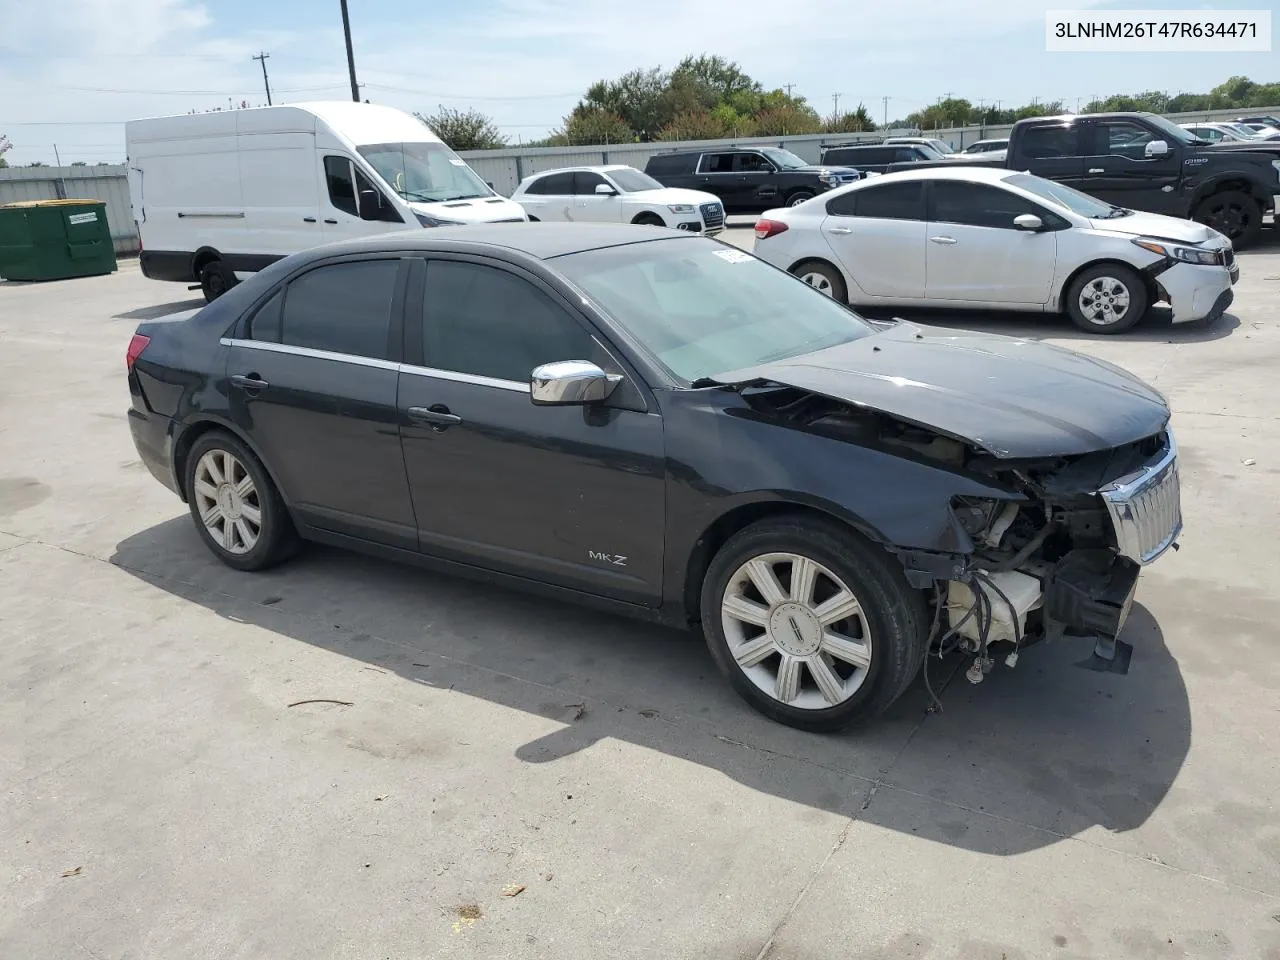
[0,99,1280,244]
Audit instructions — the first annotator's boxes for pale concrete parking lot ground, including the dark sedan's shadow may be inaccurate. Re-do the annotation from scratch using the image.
[0,229,1280,960]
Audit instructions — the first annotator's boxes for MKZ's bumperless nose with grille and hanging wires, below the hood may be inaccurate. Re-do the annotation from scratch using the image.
[942,431,1183,682]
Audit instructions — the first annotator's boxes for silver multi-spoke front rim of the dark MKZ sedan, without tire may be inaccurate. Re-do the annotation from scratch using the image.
[721,553,872,710]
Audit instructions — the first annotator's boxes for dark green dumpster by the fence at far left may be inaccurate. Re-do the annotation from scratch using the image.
[0,200,115,280]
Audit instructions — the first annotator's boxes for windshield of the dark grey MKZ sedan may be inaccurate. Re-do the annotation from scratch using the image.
[554,238,874,383]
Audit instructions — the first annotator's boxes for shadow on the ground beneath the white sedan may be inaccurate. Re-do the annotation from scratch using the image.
[858,306,1240,343]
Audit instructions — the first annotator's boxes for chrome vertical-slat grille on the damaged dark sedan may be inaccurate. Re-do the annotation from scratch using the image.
[1098,433,1183,563]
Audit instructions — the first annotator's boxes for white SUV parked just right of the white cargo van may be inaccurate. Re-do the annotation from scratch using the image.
[511,165,724,237]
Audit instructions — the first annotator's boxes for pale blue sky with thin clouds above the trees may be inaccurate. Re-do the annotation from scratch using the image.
[0,0,1280,165]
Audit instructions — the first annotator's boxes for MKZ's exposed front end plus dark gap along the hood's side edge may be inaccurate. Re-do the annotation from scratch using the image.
[742,384,1181,682]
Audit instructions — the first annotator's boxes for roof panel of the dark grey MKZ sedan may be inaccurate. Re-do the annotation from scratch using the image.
[294,221,700,260]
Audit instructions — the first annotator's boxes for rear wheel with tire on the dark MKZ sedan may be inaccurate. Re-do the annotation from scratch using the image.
[186,430,296,571]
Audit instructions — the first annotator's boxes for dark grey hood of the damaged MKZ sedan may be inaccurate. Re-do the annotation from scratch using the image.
[710,323,1169,458]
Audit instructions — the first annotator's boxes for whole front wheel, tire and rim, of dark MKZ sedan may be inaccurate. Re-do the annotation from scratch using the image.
[701,516,927,731]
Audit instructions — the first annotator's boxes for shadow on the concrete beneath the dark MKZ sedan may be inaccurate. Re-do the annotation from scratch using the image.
[111,516,1190,855]
